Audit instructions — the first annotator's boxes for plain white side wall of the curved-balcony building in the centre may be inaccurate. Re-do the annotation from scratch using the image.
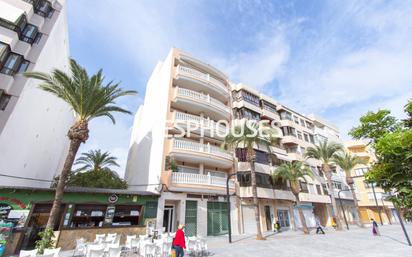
[125,51,173,192]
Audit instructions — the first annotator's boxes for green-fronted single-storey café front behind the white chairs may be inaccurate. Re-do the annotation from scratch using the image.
[0,185,158,254]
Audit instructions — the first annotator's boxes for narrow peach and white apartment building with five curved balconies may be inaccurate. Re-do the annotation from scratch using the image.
[125,49,237,236]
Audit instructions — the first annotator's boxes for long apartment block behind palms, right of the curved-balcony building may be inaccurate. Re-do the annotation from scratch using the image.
[232,84,356,234]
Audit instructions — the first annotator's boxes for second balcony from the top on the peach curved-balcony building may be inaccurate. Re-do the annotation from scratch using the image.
[173,87,231,120]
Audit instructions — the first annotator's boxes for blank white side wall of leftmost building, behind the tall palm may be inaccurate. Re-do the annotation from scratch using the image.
[0,1,74,187]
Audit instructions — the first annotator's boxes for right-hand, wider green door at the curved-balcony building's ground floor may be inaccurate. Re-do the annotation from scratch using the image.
[207,202,229,236]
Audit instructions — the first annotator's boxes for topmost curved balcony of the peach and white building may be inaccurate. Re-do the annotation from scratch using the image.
[176,65,229,99]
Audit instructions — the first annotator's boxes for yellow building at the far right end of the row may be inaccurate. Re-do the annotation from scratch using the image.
[345,141,397,223]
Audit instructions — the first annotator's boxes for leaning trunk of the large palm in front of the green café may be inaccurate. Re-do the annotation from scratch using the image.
[46,121,89,229]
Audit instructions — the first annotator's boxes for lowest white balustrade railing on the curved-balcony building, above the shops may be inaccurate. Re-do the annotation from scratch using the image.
[172,167,235,188]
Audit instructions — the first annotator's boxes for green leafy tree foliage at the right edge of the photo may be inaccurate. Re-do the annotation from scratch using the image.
[351,100,412,216]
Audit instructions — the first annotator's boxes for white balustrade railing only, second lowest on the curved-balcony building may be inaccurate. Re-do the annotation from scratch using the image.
[173,139,232,159]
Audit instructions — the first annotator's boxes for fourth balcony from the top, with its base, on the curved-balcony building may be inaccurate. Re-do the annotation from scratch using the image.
[170,139,233,168]
